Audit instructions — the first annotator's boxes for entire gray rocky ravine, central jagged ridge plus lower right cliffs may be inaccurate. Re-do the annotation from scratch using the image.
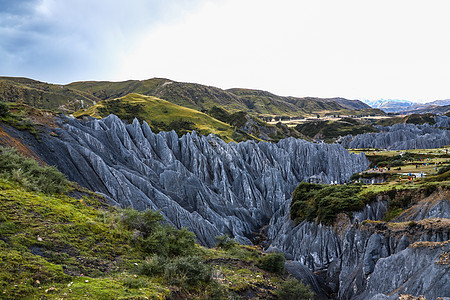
[7,116,450,299]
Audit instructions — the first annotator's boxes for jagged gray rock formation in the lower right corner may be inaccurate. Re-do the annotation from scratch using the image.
[267,196,450,299]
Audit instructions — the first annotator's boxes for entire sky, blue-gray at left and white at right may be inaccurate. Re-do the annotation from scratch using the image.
[0,0,450,102]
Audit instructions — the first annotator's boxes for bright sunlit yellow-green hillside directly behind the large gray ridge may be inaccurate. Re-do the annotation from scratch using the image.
[74,94,239,141]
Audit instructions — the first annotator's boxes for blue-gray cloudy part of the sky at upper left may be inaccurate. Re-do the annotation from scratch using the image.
[0,0,197,83]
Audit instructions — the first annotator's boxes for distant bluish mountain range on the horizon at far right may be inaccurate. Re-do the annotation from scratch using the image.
[362,99,450,114]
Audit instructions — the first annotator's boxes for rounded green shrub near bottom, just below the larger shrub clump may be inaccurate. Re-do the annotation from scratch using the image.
[164,256,212,287]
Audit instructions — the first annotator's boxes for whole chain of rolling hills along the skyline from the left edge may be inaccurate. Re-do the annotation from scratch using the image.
[0,77,384,117]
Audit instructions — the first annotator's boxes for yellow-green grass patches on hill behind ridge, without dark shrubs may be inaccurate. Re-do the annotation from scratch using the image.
[74,94,241,141]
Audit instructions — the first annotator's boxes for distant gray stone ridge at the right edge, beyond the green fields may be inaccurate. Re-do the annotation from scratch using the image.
[338,116,450,150]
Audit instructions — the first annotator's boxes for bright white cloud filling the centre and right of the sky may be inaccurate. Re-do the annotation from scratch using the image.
[116,0,450,100]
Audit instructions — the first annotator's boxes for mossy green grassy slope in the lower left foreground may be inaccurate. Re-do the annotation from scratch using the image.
[0,179,302,299]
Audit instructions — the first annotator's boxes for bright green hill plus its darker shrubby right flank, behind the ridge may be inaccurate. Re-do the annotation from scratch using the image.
[74,94,303,142]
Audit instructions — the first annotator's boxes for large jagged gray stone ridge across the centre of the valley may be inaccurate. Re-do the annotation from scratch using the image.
[22,115,368,246]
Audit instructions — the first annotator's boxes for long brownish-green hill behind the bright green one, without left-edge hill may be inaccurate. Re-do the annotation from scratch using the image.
[68,78,384,117]
